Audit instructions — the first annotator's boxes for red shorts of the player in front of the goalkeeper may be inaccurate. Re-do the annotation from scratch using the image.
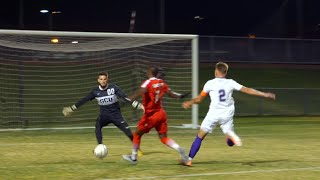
[137,109,168,134]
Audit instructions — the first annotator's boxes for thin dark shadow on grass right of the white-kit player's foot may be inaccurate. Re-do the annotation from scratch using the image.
[195,159,289,166]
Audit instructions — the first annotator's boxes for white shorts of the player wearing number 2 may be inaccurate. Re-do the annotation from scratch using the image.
[200,115,234,134]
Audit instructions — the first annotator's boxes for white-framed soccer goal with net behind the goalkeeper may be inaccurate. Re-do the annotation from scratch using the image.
[0,30,198,128]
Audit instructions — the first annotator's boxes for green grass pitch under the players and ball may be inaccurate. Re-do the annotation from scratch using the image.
[0,117,320,180]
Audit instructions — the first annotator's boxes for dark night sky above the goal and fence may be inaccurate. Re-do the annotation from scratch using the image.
[0,0,320,38]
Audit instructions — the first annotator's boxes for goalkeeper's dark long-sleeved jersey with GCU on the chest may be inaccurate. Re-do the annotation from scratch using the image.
[75,84,127,114]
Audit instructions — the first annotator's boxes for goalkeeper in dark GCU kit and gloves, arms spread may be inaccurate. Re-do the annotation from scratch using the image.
[62,72,144,155]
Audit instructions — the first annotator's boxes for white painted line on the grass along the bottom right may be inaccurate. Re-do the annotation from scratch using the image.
[99,166,320,180]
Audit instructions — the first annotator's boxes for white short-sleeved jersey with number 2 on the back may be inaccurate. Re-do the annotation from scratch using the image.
[202,78,242,117]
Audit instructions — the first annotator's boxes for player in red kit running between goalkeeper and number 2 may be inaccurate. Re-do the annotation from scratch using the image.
[123,66,188,164]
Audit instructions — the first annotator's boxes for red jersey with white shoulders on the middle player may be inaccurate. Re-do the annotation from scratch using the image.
[140,77,169,114]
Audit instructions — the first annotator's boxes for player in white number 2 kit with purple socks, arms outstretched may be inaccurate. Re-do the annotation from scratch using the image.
[182,62,275,166]
